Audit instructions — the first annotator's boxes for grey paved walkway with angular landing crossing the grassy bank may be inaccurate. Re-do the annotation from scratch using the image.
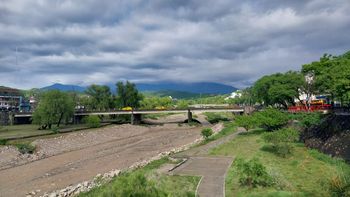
[172,128,245,197]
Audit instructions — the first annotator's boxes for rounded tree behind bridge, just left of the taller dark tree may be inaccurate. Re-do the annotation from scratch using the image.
[85,84,112,110]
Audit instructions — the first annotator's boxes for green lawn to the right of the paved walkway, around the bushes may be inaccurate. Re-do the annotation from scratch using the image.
[210,130,350,196]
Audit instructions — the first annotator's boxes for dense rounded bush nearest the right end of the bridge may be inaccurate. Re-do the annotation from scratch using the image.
[254,108,288,131]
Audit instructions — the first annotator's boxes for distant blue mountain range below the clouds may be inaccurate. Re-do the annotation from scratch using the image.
[41,82,237,95]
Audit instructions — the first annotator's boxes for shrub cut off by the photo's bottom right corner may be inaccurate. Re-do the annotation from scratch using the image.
[329,172,350,197]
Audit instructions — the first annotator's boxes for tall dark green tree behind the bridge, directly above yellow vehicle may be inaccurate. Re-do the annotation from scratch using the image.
[116,81,143,108]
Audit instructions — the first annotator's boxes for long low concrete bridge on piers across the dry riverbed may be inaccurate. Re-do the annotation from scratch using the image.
[13,108,245,124]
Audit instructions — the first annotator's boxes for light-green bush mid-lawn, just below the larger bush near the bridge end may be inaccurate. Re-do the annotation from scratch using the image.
[262,128,300,157]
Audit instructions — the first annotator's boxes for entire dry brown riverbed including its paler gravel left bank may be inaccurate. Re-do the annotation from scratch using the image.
[0,116,201,197]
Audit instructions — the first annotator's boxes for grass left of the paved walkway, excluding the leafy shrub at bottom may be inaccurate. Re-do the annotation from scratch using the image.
[79,158,200,197]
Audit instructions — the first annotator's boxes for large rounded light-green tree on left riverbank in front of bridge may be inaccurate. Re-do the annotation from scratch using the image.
[33,90,74,129]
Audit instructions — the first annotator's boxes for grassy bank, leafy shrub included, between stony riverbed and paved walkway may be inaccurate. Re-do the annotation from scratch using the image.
[79,158,200,197]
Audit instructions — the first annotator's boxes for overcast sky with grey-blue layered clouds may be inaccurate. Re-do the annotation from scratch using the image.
[0,0,350,88]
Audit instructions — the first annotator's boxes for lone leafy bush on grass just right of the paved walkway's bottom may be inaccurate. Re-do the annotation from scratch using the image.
[235,158,274,188]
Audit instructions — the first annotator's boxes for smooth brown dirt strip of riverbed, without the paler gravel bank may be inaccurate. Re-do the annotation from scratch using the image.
[0,125,200,197]
